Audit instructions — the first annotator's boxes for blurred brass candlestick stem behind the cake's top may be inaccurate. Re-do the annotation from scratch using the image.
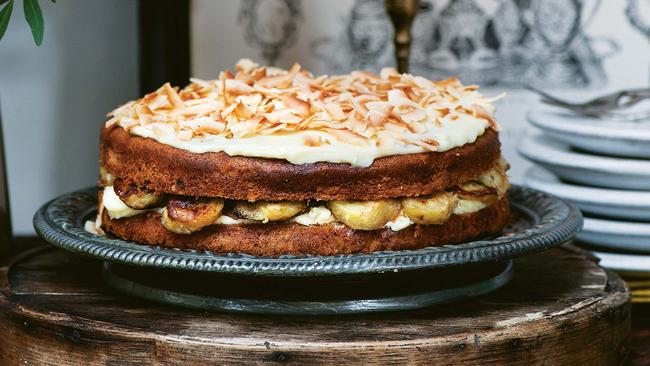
[385,0,420,73]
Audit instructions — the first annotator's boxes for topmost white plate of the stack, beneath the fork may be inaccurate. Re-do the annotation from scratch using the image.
[528,106,650,158]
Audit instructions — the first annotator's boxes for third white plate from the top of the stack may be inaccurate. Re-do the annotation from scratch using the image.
[524,167,650,221]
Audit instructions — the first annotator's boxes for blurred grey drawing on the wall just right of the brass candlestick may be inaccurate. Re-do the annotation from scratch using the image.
[412,0,618,87]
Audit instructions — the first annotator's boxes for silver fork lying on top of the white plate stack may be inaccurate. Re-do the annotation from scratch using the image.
[526,86,650,121]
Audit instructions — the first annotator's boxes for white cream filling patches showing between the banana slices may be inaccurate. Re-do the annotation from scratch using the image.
[102,186,487,231]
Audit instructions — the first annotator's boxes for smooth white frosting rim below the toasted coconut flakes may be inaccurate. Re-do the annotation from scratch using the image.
[125,114,489,167]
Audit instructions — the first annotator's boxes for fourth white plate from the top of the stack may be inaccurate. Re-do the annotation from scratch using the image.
[578,217,650,253]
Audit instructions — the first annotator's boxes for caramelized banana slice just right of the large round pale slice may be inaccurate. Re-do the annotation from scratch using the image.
[402,192,458,225]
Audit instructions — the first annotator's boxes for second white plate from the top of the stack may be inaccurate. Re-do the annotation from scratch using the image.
[518,134,650,191]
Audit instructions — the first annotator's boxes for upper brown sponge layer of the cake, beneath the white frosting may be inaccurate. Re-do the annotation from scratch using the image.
[100,126,500,200]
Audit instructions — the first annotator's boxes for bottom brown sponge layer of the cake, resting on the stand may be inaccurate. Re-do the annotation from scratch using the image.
[103,196,510,256]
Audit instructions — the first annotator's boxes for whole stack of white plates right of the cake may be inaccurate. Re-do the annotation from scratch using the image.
[519,106,650,276]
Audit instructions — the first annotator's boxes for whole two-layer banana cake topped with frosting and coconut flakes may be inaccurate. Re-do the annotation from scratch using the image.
[93,59,510,256]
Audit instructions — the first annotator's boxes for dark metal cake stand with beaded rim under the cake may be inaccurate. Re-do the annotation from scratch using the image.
[34,186,582,315]
